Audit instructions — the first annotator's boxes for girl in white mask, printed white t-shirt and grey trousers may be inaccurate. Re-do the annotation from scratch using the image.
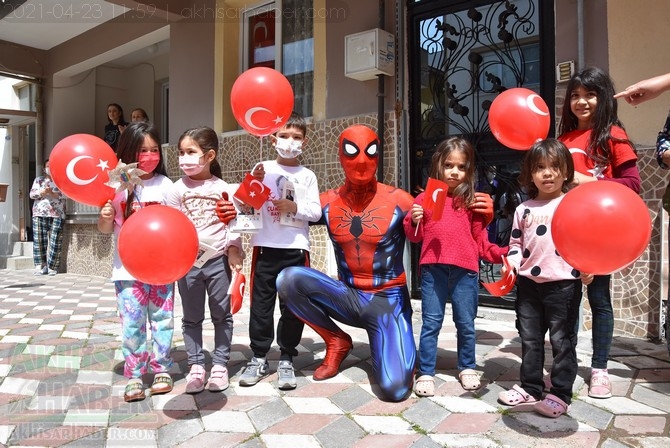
[168,127,243,394]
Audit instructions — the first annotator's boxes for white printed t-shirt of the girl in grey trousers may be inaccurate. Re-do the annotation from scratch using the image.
[167,176,243,258]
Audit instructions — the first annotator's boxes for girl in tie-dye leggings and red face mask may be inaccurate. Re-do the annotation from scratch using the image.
[98,123,174,401]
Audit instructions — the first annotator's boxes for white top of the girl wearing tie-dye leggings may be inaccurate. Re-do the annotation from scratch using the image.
[112,174,172,281]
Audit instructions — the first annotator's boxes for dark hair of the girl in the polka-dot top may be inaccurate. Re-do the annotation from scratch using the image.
[519,138,575,199]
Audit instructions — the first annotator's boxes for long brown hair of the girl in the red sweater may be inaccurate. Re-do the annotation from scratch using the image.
[429,137,475,207]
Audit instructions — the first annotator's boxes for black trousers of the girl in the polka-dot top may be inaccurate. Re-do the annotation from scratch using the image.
[514,277,582,403]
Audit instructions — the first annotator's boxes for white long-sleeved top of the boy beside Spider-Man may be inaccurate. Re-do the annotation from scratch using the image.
[251,160,321,251]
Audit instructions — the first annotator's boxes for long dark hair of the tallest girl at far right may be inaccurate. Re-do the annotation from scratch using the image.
[559,67,635,165]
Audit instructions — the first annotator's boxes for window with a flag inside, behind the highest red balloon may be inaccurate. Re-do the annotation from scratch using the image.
[242,0,314,117]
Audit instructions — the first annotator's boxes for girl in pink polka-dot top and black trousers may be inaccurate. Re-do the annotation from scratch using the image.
[498,139,592,417]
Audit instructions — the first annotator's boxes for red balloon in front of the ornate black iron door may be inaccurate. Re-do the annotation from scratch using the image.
[489,87,551,150]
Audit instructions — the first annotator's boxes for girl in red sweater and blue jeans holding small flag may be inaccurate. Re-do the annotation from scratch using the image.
[404,137,507,397]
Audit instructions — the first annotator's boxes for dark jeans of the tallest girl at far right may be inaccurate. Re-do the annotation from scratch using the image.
[586,275,614,369]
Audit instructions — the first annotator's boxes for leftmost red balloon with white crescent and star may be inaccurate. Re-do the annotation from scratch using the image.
[49,134,118,207]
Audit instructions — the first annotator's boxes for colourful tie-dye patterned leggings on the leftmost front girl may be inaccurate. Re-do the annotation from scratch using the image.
[114,280,174,378]
